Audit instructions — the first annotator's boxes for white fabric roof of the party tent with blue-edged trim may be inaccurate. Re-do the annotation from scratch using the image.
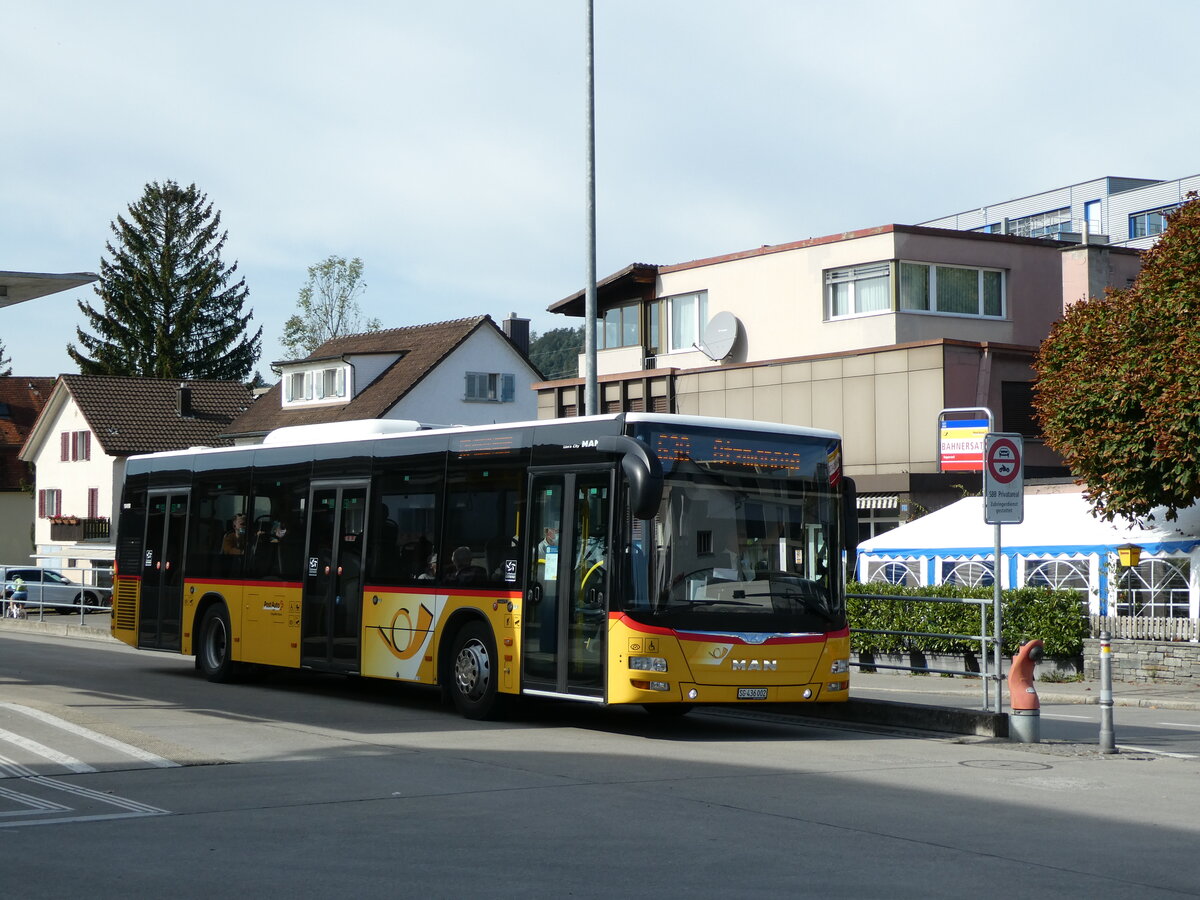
[859,493,1200,556]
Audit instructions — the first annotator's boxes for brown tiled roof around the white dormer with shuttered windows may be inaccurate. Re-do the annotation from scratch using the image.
[229,316,494,434]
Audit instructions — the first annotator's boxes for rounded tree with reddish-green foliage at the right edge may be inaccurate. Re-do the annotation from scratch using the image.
[1034,199,1200,520]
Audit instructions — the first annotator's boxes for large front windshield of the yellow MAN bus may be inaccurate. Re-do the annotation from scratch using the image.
[625,430,846,634]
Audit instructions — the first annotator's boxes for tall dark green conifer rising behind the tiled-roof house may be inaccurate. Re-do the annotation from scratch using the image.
[67,181,263,380]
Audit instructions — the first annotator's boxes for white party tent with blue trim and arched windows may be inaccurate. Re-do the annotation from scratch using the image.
[858,492,1200,618]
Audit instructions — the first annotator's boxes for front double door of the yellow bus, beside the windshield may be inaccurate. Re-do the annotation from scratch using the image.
[521,467,613,700]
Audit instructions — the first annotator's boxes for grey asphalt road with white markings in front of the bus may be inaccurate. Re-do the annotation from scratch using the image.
[0,632,1200,900]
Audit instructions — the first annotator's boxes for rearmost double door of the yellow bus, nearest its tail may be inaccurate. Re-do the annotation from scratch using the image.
[138,491,187,650]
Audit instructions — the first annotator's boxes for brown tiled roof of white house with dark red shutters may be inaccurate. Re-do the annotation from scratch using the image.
[61,374,252,456]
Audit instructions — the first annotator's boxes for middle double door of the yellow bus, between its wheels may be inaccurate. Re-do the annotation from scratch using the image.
[300,482,367,672]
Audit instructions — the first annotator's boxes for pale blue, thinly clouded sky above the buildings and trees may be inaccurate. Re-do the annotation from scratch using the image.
[0,0,1200,380]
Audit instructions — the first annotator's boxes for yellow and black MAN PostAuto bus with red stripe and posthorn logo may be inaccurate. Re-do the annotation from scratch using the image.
[112,413,857,719]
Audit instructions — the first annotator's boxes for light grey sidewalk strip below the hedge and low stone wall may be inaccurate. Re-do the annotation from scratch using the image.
[850,670,1200,712]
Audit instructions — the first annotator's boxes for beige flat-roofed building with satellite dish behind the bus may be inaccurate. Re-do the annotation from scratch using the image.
[538,226,1140,530]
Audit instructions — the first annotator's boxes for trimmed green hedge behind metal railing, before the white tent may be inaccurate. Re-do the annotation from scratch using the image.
[846,582,1088,658]
